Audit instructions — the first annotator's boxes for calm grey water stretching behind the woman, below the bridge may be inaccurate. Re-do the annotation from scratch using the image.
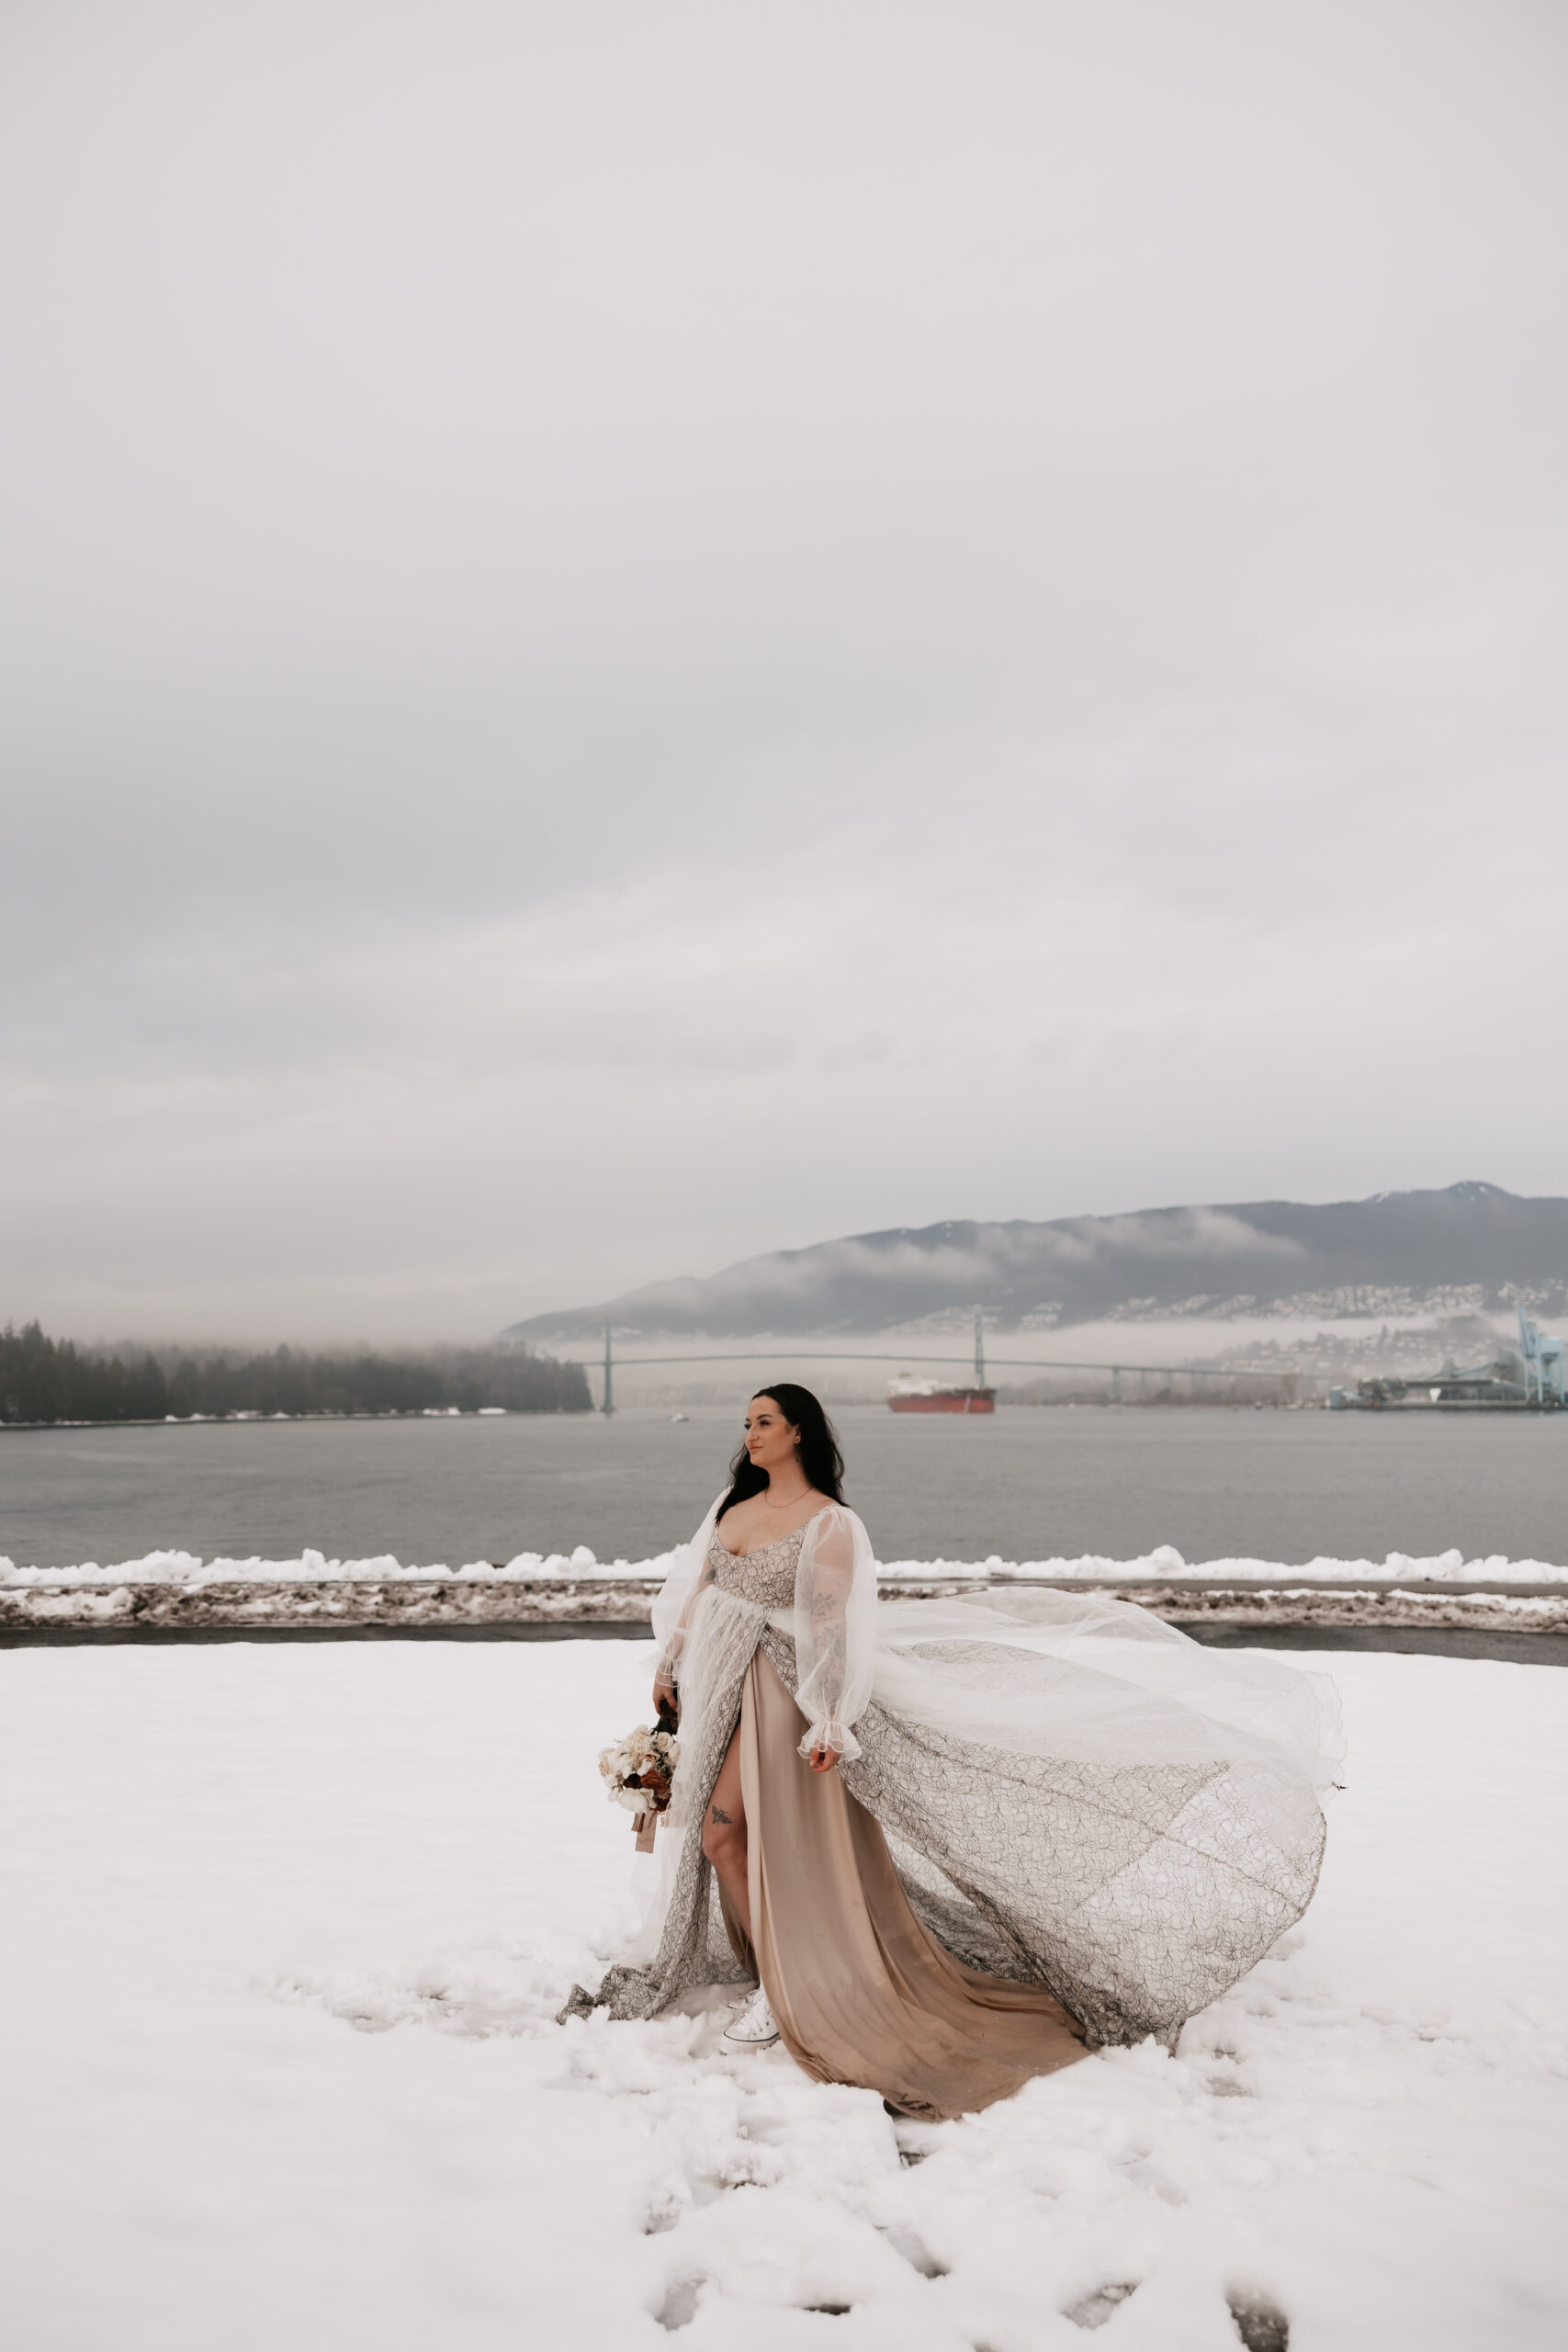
[0,1404,1568,1566]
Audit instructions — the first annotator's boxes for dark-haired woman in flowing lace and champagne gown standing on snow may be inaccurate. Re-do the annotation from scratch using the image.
[562,1381,1342,2117]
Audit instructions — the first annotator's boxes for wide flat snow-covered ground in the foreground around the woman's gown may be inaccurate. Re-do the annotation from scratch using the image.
[0,1642,1568,2352]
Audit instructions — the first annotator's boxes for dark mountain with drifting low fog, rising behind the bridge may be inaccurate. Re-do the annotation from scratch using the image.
[505,1183,1568,1340]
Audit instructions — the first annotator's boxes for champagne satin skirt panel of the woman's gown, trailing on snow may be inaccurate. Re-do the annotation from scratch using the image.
[724,1649,1084,2117]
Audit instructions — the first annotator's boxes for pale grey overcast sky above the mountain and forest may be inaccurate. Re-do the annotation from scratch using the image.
[0,0,1568,1340]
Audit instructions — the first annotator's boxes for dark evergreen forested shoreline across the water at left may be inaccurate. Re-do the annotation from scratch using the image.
[0,1322,592,1425]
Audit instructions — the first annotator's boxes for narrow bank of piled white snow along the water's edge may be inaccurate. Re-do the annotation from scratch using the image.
[0,1543,1568,1590]
